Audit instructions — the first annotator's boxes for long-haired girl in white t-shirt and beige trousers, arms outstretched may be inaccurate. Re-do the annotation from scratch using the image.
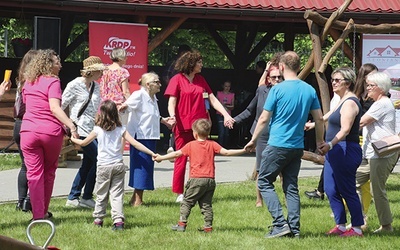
[71,100,156,230]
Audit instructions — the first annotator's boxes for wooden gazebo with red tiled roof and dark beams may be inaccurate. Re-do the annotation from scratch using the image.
[0,0,400,149]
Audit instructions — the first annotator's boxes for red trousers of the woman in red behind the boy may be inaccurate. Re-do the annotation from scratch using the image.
[172,130,194,194]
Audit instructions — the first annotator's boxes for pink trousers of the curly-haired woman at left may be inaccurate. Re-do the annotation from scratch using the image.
[21,132,63,220]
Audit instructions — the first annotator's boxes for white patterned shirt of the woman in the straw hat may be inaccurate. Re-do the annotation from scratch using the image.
[61,77,101,137]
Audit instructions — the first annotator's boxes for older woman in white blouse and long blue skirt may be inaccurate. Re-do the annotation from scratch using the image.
[120,72,171,206]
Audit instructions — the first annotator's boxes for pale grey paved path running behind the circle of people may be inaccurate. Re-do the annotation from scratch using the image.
[0,154,322,203]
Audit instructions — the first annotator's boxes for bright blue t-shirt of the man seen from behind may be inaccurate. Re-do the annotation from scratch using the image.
[264,80,321,148]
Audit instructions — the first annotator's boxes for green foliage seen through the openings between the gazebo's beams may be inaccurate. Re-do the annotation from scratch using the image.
[0,18,352,69]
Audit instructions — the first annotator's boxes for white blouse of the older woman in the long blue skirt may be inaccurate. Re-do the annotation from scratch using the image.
[125,88,160,140]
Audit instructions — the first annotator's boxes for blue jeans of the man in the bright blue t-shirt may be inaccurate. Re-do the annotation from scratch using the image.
[258,145,303,234]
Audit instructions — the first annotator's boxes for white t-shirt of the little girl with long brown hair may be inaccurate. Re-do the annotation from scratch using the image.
[93,126,126,166]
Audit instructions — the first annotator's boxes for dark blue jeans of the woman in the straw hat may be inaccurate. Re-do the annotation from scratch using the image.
[68,136,97,200]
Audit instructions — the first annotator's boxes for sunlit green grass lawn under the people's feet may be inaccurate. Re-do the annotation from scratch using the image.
[0,174,400,250]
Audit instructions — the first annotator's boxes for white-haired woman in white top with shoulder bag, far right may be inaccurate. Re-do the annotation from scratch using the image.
[360,72,398,233]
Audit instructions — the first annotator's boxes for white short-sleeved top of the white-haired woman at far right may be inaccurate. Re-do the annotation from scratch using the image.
[365,98,396,159]
